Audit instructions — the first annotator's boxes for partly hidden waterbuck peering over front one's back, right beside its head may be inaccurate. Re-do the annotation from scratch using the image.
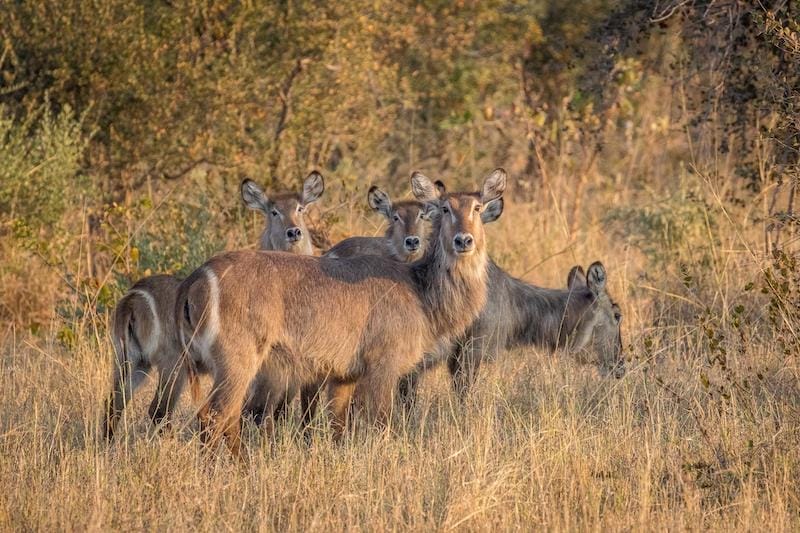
[325,185,430,263]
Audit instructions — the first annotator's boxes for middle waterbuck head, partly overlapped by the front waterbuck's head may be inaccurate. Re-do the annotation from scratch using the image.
[367,185,431,263]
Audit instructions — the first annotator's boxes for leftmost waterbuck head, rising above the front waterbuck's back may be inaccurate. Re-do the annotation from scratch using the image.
[241,171,325,255]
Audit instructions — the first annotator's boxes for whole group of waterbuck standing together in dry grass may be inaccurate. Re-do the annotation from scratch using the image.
[103,169,625,455]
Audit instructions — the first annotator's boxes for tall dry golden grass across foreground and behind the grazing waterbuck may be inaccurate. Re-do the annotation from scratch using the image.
[0,182,800,531]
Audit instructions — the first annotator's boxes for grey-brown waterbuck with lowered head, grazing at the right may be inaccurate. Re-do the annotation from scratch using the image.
[400,260,625,404]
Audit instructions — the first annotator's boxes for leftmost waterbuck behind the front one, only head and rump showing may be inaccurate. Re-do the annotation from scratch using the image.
[103,172,324,440]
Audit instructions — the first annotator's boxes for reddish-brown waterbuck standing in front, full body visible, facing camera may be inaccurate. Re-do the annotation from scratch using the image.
[175,169,506,454]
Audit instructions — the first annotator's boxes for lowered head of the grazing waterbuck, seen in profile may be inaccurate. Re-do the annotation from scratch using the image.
[567,261,625,378]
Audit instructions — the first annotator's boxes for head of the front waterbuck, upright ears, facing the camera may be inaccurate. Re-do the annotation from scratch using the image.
[411,168,507,264]
